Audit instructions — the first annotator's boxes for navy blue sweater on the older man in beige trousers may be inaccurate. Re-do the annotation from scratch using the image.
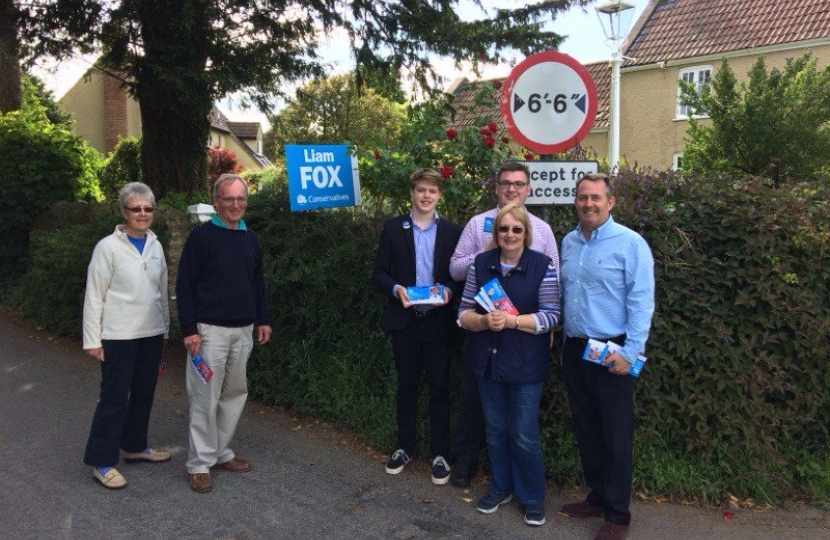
[176,222,271,337]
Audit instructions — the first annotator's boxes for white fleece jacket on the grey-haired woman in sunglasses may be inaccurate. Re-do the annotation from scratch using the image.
[83,226,170,349]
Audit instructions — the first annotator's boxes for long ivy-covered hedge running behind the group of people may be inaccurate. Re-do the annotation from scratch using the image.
[14,171,830,506]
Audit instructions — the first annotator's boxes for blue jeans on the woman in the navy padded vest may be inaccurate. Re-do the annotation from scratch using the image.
[478,378,545,504]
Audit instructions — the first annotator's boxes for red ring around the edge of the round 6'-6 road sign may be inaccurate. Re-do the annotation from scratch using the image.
[499,51,597,154]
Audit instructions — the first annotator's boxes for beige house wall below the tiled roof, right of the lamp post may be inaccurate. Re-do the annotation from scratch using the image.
[624,45,830,169]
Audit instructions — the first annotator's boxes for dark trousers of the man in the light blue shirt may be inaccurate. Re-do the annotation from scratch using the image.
[562,338,634,525]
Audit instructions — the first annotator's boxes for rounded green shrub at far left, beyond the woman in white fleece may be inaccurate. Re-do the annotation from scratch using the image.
[0,111,101,275]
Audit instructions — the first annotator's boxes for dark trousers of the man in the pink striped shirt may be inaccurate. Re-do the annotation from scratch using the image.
[453,343,485,464]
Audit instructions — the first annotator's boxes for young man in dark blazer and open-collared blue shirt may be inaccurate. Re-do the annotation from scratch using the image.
[372,169,462,485]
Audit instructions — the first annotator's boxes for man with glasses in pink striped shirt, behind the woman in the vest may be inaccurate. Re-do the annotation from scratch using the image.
[450,161,559,487]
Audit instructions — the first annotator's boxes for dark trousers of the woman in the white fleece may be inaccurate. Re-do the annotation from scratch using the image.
[84,335,163,467]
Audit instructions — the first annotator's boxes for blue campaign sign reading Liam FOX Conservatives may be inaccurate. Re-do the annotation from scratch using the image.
[285,144,361,212]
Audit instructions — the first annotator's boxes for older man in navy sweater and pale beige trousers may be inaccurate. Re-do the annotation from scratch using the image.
[176,174,271,493]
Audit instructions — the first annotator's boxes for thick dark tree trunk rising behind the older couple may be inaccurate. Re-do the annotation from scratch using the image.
[132,0,213,198]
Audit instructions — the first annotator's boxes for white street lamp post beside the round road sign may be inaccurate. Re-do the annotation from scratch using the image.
[596,0,634,172]
